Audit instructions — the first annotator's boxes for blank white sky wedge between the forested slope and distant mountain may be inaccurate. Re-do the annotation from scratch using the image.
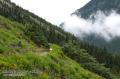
[11,0,90,25]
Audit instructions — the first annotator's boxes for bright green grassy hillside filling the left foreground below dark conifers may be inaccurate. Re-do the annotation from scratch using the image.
[0,16,104,79]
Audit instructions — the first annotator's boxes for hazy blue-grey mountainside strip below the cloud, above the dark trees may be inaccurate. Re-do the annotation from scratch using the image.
[82,34,120,53]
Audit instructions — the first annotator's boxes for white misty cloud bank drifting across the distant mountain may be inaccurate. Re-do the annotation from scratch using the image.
[63,11,120,40]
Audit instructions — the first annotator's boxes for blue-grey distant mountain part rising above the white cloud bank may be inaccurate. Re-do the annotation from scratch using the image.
[73,0,120,19]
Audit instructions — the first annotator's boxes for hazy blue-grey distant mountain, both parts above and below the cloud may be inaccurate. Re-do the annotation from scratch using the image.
[73,0,120,52]
